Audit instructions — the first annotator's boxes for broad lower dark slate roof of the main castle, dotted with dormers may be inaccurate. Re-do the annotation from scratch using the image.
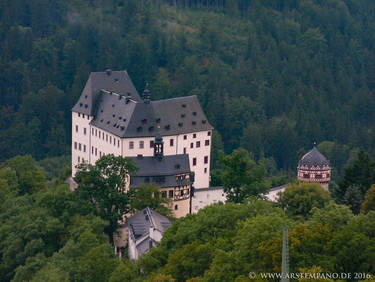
[91,94,213,137]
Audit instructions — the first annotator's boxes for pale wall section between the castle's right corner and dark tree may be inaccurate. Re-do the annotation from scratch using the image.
[191,187,227,213]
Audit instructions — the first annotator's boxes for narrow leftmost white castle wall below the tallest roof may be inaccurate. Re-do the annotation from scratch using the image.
[72,112,92,176]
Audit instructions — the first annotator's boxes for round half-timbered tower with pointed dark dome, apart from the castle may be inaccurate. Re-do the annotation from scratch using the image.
[297,146,331,190]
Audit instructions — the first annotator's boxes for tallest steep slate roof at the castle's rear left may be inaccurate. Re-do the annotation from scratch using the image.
[72,70,141,115]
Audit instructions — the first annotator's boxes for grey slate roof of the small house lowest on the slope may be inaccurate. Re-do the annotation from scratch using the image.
[127,207,172,239]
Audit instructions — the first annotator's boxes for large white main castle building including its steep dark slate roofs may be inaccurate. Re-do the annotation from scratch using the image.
[72,70,213,217]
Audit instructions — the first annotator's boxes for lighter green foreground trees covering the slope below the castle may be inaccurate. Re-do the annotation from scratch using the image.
[0,155,375,282]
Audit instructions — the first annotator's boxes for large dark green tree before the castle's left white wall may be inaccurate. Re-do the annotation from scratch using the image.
[74,155,136,242]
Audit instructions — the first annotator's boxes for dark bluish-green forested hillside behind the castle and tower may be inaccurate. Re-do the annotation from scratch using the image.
[0,0,375,177]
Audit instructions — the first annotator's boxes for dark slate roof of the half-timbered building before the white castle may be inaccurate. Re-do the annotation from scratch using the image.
[130,154,191,188]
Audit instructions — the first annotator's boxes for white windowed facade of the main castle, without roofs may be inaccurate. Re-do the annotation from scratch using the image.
[72,112,212,189]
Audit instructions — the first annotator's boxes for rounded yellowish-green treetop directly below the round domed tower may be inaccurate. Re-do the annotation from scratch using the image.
[279,182,331,218]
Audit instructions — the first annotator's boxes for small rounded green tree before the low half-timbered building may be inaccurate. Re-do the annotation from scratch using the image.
[130,184,173,217]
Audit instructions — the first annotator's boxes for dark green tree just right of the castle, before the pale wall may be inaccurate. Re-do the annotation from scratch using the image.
[219,149,267,203]
